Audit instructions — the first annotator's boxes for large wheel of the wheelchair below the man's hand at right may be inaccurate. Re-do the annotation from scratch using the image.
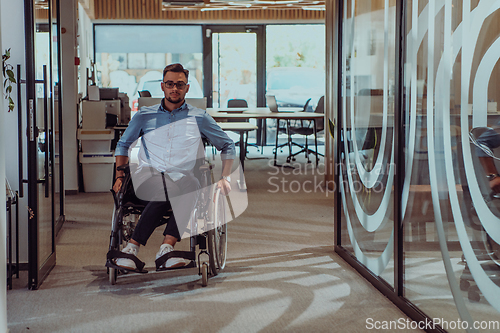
[208,189,227,276]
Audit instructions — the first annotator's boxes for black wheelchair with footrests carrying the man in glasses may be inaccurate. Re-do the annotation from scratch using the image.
[105,160,229,287]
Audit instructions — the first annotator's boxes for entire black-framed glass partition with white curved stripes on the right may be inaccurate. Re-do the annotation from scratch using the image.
[328,0,500,332]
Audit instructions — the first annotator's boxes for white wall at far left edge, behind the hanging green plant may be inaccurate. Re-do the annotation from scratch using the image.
[0,0,28,264]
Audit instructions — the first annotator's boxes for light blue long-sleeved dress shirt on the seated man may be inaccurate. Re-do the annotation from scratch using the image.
[115,103,236,187]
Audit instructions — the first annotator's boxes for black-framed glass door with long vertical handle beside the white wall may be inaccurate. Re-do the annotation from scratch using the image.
[25,0,59,289]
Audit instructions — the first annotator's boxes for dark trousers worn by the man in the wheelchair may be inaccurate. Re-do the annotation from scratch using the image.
[132,174,200,245]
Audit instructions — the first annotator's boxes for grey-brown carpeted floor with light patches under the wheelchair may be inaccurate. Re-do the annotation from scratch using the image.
[7,149,422,333]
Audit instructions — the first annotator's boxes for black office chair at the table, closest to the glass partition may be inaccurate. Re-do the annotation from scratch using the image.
[287,96,325,163]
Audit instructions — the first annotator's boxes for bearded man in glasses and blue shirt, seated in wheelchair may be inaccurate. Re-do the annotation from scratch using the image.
[113,64,235,271]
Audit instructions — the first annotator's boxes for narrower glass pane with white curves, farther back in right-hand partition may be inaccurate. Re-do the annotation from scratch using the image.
[340,1,396,285]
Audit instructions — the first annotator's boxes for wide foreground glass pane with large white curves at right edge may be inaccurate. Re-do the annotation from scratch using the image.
[402,1,500,326]
